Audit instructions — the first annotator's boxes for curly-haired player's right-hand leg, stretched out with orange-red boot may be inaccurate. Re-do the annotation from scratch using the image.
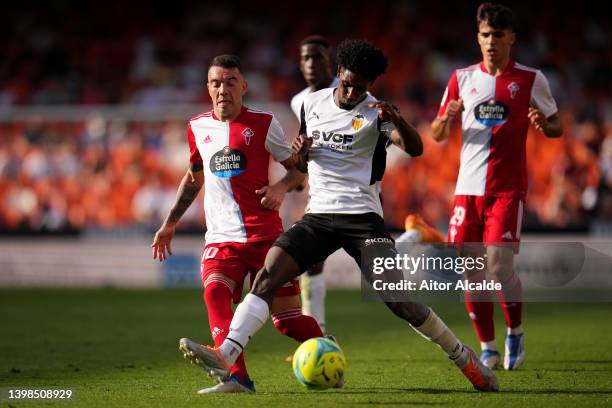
[343,214,498,391]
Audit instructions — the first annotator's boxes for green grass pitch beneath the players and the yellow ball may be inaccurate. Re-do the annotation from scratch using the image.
[0,290,612,408]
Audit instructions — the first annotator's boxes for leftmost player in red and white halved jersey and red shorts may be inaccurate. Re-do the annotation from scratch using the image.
[151,55,323,393]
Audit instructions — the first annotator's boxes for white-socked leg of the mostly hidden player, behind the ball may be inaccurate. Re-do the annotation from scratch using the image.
[300,262,326,332]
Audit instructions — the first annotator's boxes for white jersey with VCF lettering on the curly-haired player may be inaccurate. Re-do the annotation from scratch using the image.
[300,88,395,217]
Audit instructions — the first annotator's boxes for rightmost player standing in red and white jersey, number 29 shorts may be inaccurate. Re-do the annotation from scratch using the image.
[432,3,562,370]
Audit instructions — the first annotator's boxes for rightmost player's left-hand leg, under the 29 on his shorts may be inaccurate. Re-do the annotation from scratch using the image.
[448,195,500,368]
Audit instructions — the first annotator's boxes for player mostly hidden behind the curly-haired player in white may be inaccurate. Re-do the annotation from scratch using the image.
[291,35,338,332]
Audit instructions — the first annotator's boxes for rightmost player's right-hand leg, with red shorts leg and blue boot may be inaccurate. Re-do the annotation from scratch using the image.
[485,197,525,370]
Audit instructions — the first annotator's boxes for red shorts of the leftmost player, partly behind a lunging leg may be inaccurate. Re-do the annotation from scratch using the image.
[200,241,300,303]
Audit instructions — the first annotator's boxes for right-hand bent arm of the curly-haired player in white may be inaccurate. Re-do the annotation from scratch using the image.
[370,101,423,157]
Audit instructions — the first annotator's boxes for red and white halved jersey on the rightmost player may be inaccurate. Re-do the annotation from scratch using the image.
[438,61,557,199]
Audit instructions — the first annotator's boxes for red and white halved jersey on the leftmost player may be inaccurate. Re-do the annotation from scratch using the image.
[187,106,291,244]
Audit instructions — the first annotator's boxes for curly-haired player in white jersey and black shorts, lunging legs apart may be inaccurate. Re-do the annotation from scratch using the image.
[185,40,498,391]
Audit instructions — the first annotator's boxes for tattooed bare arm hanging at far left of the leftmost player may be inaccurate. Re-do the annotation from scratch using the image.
[151,165,204,262]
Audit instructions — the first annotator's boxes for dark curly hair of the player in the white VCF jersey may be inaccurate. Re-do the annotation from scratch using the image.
[337,38,387,82]
